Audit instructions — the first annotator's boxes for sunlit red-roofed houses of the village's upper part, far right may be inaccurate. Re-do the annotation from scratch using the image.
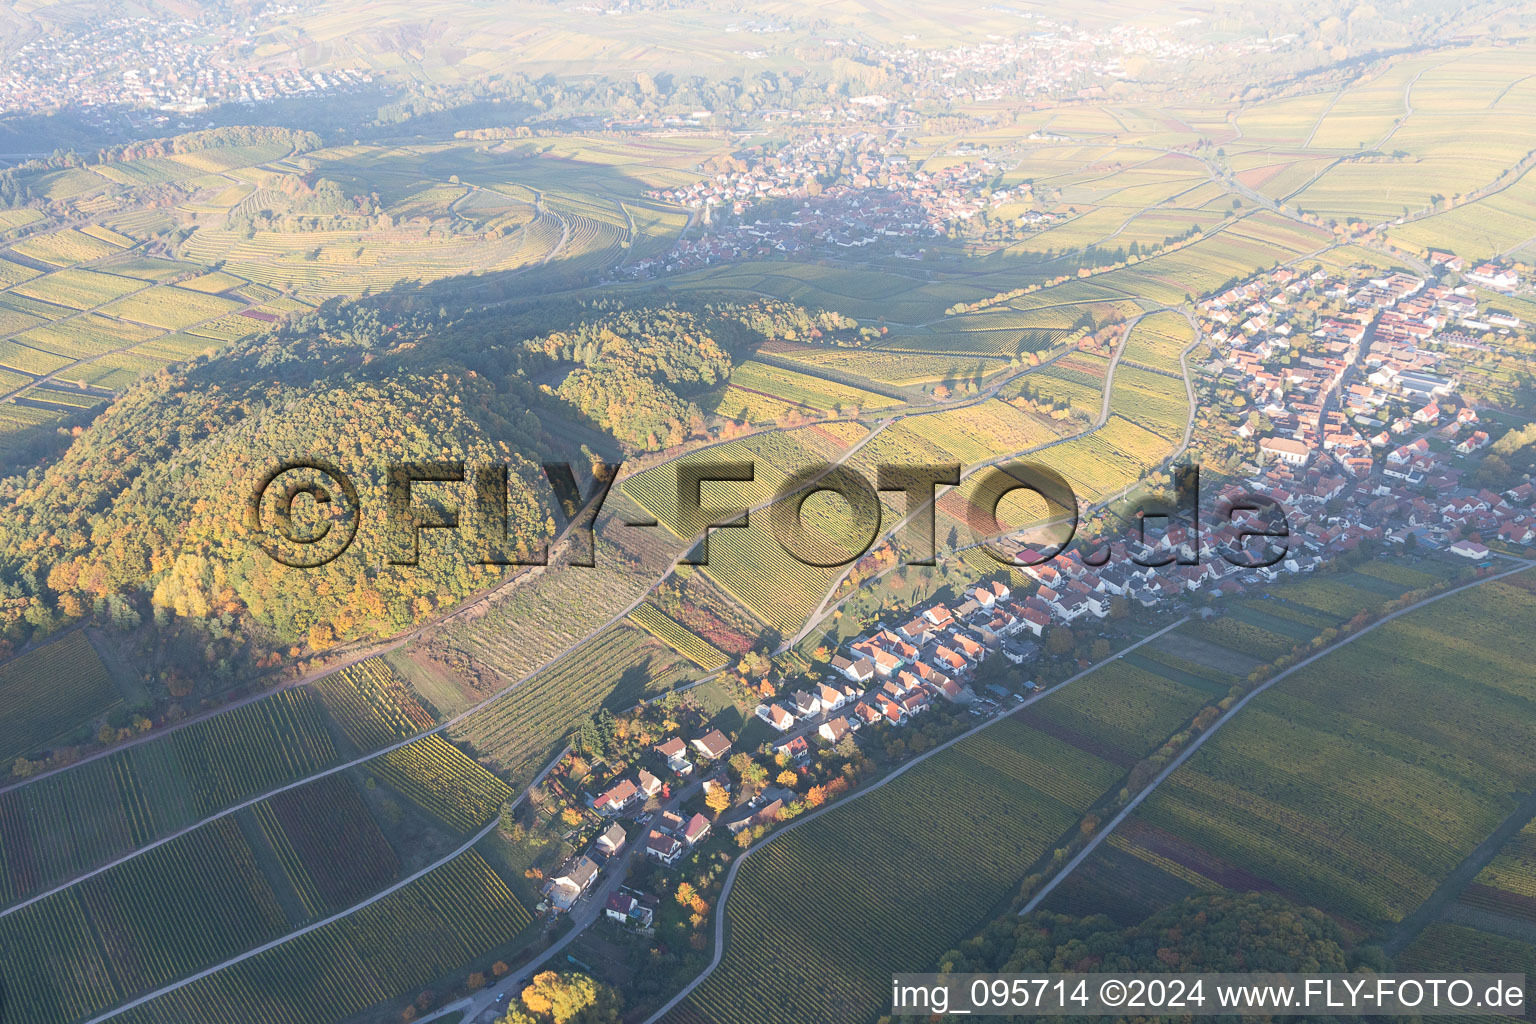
[1200,253,1519,484]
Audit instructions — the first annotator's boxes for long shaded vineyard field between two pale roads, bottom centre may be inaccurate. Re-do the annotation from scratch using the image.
[667,641,1207,1024]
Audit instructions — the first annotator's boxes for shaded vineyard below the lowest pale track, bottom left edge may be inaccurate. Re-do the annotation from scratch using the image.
[117,851,531,1024]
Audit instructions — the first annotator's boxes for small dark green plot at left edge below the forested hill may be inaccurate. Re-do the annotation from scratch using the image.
[0,629,121,765]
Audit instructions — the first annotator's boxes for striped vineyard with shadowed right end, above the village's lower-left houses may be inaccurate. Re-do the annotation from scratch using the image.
[455,626,694,783]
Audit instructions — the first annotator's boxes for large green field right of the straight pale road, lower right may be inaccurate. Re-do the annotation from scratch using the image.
[1063,577,1536,933]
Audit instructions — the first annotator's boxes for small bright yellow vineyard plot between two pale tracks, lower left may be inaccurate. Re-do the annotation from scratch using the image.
[367,732,511,834]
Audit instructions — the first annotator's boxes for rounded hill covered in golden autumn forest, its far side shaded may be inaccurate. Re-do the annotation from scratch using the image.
[0,288,859,688]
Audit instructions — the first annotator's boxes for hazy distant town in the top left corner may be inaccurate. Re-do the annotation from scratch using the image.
[0,5,372,114]
